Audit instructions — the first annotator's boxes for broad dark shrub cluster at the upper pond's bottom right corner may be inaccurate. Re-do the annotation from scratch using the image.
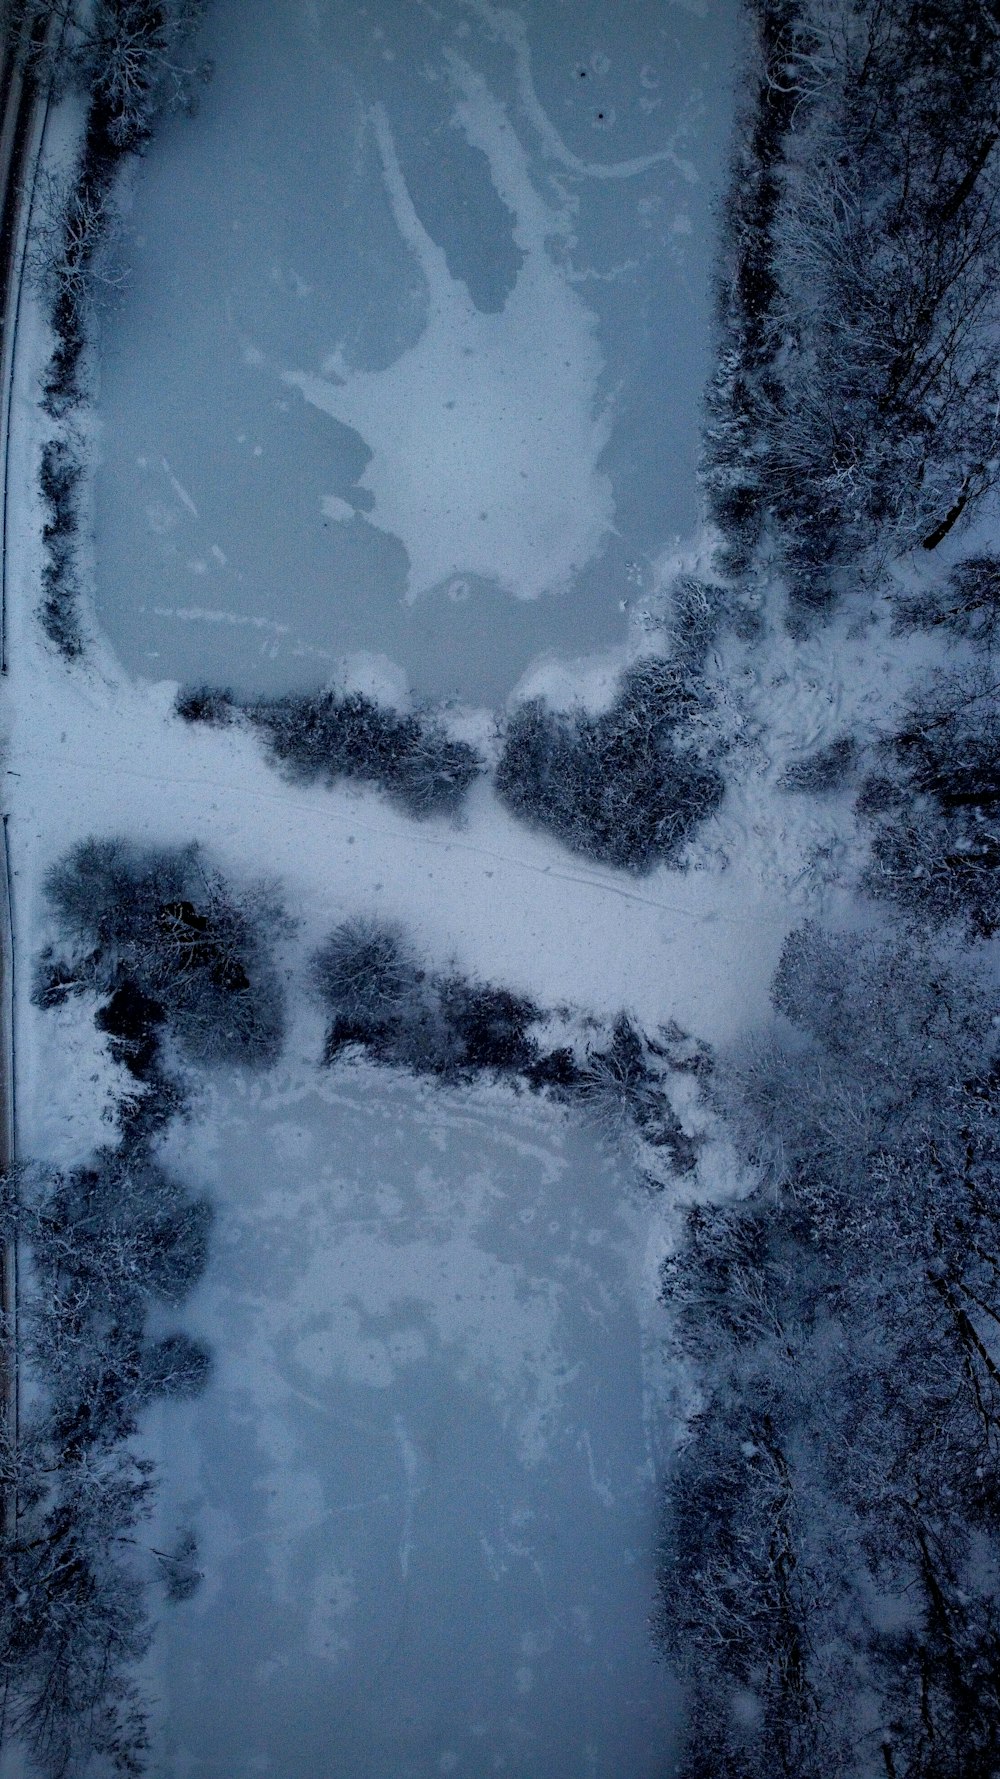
[496,660,724,872]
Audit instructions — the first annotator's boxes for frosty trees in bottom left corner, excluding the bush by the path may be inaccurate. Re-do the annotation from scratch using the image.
[0,1142,210,1775]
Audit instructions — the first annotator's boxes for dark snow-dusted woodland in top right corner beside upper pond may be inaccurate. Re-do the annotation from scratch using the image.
[705,0,1000,608]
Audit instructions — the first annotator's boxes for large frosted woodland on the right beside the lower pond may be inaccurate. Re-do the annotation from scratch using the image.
[658,927,1000,1779]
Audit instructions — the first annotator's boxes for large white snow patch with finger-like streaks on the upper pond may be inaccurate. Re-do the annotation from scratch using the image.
[283,80,614,600]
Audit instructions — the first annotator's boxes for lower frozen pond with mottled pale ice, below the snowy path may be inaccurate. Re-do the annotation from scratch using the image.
[153,1069,674,1779]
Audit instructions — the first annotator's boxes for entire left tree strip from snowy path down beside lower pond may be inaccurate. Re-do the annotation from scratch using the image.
[0,841,285,1775]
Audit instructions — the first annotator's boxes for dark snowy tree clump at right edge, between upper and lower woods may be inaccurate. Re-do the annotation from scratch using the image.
[858,671,1000,938]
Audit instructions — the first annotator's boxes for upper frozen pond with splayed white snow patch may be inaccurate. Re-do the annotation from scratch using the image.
[96,0,737,703]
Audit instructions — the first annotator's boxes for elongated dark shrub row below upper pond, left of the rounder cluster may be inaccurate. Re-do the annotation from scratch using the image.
[174,687,484,818]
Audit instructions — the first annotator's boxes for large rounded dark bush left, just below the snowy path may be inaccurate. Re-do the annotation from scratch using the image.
[36,840,286,1066]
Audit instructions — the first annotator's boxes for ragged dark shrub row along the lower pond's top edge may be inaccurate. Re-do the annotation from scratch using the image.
[313,916,710,1172]
